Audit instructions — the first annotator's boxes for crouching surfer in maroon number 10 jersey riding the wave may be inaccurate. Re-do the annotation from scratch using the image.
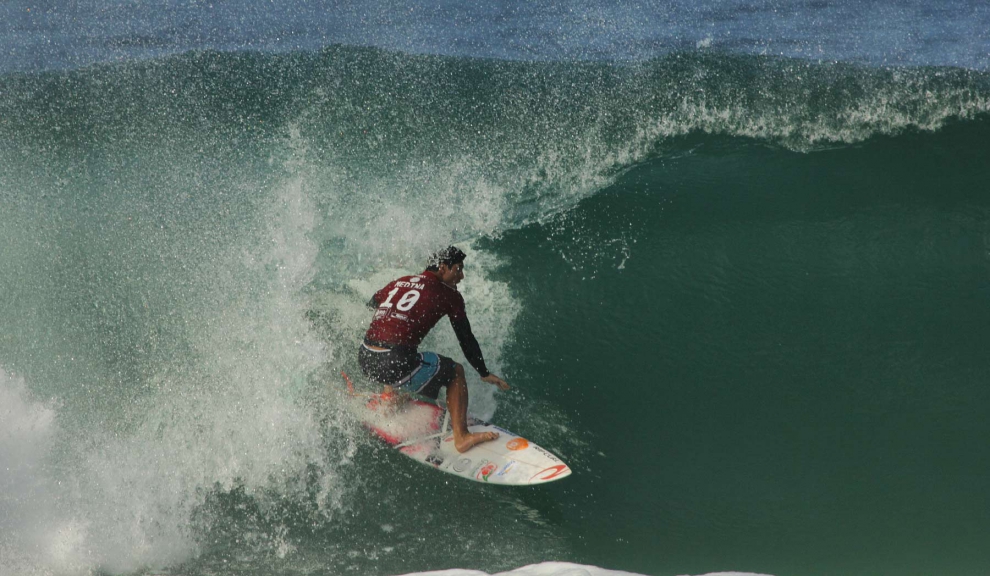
[358,246,509,452]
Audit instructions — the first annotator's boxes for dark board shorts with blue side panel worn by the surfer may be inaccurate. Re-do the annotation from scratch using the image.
[358,342,457,400]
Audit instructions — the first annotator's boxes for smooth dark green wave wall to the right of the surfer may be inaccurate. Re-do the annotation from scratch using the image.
[484,122,990,574]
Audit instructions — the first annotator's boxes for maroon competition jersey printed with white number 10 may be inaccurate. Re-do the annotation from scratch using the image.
[365,272,470,349]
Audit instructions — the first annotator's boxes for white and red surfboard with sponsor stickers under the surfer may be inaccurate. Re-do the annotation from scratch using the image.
[345,375,571,486]
